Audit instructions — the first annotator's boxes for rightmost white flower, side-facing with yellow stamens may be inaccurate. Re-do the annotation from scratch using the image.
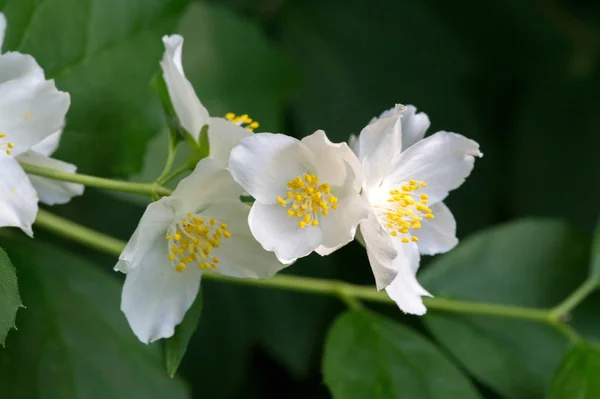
[352,105,482,314]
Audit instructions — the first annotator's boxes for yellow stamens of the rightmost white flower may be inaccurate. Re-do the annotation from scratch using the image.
[383,180,434,243]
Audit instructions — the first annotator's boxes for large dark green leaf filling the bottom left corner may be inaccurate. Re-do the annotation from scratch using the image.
[0,238,188,399]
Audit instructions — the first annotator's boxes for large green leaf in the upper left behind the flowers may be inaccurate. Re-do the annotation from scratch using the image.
[2,0,188,175]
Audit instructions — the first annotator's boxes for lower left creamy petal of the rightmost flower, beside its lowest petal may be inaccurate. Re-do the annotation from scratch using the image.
[360,212,398,290]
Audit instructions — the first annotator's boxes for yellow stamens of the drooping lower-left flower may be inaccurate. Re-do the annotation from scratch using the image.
[166,213,231,272]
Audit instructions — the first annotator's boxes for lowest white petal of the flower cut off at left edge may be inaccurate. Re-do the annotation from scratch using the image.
[0,154,38,237]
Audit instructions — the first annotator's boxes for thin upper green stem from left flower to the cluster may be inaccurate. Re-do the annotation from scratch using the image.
[21,163,171,196]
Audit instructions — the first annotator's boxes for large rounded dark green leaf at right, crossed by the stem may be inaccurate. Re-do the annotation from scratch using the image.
[420,219,589,399]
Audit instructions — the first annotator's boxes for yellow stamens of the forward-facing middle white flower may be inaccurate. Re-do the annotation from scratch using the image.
[277,174,338,228]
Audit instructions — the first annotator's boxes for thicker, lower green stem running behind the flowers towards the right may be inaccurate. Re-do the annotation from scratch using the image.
[36,210,560,325]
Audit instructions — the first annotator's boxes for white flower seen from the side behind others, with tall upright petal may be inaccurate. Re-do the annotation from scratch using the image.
[160,35,259,167]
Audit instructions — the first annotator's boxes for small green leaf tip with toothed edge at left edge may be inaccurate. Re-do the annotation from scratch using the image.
[0,248,23,346]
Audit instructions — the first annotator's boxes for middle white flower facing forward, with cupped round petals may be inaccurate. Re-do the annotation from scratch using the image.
[229,130,367,264]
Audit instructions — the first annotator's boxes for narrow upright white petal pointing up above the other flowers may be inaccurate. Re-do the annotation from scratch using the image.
[160,35,208,142]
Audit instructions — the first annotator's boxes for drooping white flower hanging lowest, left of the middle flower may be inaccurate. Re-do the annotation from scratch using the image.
[115,158,284,343]
